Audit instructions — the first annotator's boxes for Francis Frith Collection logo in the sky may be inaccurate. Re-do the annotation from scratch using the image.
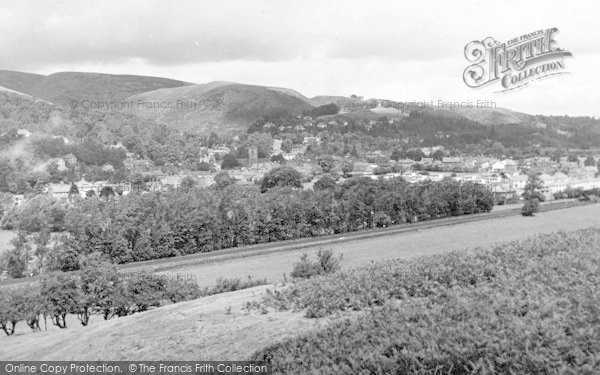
[463,28,573,91]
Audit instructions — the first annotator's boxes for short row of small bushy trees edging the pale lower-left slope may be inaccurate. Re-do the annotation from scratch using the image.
[0,254,203,336]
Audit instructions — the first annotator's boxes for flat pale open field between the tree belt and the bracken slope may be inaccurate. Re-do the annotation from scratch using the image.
[161,204,600,284]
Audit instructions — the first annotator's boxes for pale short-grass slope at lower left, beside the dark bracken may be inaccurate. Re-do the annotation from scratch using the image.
[0,286,324,361]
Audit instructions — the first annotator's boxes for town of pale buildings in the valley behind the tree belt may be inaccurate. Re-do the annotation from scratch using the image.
[24,136,600,204]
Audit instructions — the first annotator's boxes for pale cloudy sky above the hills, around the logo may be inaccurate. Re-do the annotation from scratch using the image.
[0,0,600,117]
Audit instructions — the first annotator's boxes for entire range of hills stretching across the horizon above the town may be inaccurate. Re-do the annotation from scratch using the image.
[0,70,600,148]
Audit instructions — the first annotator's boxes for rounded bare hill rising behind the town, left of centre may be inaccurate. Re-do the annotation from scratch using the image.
[128,82,312,134]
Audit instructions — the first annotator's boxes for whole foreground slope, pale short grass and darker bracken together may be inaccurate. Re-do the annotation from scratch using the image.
[0,223,600,374]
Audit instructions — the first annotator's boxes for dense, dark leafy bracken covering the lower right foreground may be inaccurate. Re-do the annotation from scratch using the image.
[253,229,600,374]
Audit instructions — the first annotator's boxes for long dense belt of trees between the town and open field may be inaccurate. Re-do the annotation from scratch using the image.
[0,173,493,272]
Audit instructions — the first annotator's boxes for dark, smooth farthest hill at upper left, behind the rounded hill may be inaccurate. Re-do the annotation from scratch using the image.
[0,70,188,105]
